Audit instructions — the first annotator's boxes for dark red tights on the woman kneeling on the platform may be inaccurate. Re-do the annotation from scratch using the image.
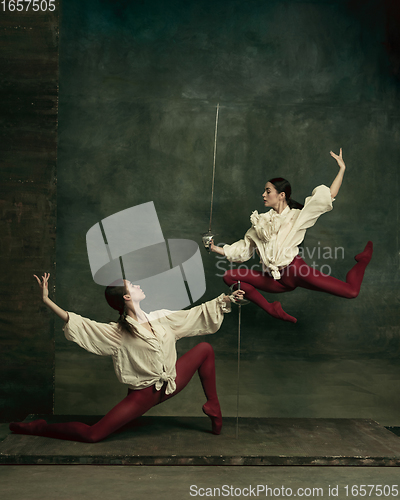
[10,342,222,443]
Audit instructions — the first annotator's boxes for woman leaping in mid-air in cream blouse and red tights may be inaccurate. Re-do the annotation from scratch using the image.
[210,149,372,323]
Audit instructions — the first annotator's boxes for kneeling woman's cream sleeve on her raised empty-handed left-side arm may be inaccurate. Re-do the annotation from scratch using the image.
[64,312,122,356]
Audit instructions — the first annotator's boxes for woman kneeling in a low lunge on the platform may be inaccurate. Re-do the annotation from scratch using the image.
[10,273,244,443]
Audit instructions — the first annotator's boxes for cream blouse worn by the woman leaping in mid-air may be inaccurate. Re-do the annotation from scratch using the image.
[223,185,334,280]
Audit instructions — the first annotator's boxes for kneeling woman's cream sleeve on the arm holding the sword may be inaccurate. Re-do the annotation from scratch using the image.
[159,294,231,340]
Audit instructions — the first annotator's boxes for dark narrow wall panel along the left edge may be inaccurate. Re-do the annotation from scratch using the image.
[0,6,59,422]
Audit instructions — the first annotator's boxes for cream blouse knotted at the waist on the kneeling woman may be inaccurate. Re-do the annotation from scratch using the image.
[64,294,231,394]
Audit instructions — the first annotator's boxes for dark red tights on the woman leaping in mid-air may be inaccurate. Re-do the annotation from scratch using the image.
[224,241,373,323]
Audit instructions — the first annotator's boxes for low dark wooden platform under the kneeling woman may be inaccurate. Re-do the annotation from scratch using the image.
[0,415,400,466]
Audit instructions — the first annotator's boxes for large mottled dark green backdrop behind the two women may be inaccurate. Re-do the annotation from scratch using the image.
[56,0,400,424]
